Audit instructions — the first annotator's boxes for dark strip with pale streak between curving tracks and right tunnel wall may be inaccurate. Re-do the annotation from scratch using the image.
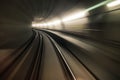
[42,30,120,80]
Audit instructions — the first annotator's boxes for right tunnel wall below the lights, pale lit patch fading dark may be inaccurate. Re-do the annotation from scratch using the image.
[55,6,120,42]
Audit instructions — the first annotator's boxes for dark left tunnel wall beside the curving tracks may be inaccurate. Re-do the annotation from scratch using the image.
[0,0,32,49]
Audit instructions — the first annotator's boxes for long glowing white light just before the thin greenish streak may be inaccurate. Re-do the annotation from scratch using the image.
[62,12,87,22]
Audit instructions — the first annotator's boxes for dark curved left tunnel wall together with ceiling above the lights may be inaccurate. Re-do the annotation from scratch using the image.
[0,0,79,48]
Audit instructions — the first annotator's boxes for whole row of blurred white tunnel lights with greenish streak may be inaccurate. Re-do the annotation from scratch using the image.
[32,0,114,28]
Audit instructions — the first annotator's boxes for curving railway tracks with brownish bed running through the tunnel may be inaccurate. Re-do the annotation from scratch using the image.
[0,30,96,80]
